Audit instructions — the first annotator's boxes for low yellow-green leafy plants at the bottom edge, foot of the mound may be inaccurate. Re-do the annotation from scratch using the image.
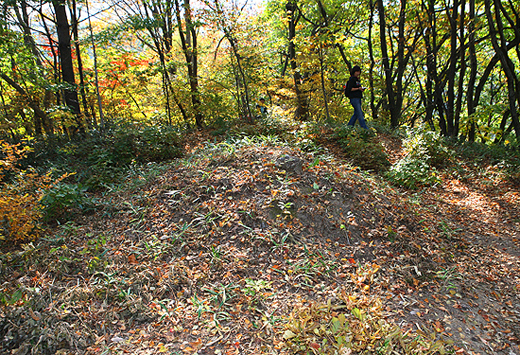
[283,265,452,355]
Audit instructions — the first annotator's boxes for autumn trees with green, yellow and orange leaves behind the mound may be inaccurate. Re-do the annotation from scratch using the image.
[0,0,520,143]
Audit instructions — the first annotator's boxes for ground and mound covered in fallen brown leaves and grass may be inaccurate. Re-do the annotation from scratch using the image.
[0,135,520,355]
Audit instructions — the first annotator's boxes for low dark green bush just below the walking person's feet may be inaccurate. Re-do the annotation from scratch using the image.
[334,125,390,171]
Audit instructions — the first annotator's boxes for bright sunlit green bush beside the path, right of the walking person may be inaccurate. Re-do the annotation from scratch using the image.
[386,128,446,189]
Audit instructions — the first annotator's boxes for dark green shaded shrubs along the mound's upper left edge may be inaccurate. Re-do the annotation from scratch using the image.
[24,126,181,192]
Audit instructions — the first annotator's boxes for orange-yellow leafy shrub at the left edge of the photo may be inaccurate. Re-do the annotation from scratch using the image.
[0,142,51,242]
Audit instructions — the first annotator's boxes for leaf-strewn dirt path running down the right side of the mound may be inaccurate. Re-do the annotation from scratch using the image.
[374,134,520,355]
